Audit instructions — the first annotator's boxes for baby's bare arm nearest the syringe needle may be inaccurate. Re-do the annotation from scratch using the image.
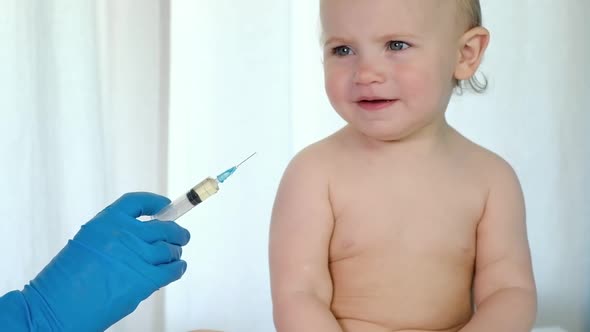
[269,147,342,332]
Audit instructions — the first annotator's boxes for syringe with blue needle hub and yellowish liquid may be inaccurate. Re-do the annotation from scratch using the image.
[150,152,256,221]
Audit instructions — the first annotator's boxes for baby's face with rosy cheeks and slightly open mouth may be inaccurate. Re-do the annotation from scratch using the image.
[321,0,463,140]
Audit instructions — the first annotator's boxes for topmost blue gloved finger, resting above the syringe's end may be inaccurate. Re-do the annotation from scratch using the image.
[108,192,170,218]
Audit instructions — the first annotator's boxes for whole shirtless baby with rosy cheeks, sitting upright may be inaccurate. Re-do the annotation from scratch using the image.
[269,0,536,332]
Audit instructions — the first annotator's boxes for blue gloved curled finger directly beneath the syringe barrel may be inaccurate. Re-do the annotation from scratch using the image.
[133,220,191,246]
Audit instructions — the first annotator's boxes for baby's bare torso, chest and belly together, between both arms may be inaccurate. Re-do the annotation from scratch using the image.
[329,162,486,330]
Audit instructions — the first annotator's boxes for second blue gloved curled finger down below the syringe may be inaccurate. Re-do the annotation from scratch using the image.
[122,234,182,265]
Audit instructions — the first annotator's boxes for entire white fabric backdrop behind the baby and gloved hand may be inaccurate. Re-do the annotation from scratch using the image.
[0,0,590,332]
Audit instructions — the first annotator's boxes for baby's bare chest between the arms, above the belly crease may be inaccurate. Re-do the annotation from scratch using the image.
[330,162,486,261]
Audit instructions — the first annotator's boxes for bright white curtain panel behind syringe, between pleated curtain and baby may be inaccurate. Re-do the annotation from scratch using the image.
[165,0,292,331]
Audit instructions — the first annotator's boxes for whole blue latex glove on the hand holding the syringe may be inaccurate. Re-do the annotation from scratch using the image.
[0,193,190,331]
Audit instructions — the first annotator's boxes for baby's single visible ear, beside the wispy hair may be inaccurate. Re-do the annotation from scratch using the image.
[455,27,490,81]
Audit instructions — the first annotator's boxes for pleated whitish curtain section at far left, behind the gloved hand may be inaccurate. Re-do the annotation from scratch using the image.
[0,0,168,331]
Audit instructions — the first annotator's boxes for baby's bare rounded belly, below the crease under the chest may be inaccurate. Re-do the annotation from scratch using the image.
[330,248,473,332]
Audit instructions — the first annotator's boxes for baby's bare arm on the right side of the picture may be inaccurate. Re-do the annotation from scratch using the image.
[461,161,536,332]
